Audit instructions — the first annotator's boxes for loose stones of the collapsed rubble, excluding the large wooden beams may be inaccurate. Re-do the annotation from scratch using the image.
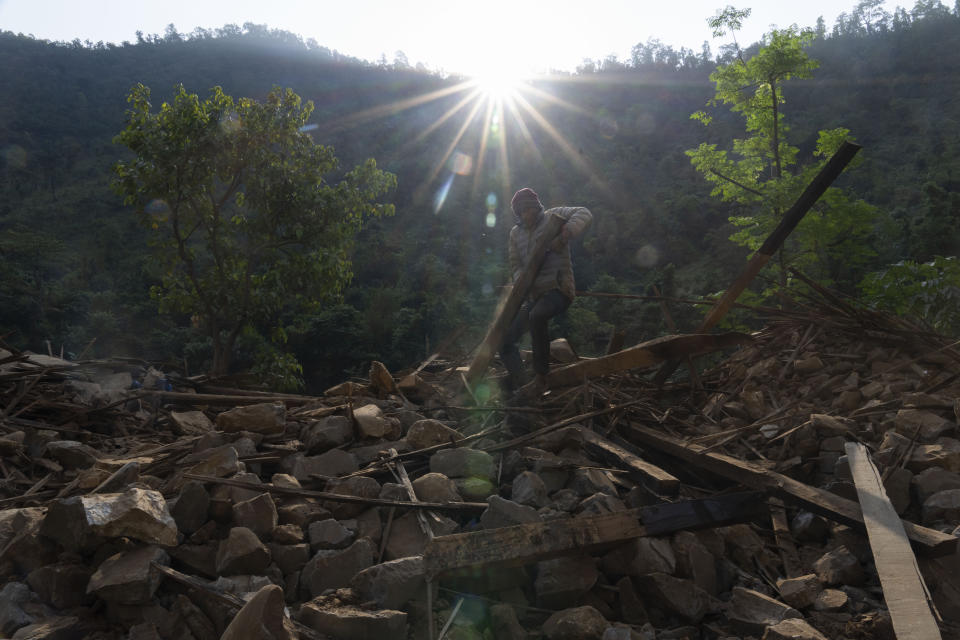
[0,310,960,640]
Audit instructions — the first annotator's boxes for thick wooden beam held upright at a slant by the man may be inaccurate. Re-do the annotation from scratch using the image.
[464,214,566,389]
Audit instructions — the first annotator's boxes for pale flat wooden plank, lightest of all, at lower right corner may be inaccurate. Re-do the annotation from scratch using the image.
[845,442,940,640]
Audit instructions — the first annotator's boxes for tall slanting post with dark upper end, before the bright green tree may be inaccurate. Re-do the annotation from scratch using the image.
[654,142,862,384]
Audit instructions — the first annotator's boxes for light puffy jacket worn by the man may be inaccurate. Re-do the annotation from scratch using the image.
[510,207,593,300]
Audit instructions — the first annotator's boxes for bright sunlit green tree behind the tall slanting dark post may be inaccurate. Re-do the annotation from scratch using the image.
[686,7,876,285]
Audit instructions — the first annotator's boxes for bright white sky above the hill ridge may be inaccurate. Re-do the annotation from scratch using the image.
[0,0,900,74]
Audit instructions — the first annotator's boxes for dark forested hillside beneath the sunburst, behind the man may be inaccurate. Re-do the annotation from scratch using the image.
[0,0,960,389]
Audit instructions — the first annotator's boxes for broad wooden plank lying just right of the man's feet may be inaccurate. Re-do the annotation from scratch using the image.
[547,332,751,387]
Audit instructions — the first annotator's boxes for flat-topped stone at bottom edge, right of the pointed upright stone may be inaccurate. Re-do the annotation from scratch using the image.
[299,602,407,640]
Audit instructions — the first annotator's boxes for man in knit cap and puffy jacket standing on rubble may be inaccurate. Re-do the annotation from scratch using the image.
[500,188,593,391]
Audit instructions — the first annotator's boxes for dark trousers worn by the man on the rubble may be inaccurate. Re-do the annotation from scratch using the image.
[500,289,570,389]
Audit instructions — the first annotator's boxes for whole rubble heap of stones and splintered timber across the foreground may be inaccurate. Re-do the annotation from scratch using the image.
[0,300,960,640]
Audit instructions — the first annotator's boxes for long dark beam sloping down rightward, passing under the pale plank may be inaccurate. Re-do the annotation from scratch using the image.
[627,425,957,556]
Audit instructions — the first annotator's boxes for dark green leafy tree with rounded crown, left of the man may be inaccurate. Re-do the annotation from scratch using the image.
[114,85,396,374]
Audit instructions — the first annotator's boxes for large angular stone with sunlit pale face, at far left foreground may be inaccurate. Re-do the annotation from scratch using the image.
[40,488,177,550]
